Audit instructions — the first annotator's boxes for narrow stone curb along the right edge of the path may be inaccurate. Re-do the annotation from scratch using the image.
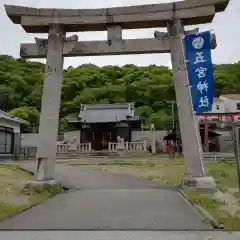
[178,189,224,230]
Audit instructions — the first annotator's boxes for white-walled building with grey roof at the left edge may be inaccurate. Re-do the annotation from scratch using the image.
[0,110,29,156]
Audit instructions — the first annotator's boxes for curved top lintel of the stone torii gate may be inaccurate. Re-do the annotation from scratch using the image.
[5,0,230,33]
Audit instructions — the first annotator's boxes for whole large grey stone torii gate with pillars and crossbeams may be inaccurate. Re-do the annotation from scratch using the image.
[5,0,229,191]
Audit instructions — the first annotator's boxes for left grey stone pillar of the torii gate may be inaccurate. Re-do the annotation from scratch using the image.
[37,25,65,180]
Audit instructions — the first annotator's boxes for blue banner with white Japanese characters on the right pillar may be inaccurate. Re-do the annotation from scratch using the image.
[184,32,214,114]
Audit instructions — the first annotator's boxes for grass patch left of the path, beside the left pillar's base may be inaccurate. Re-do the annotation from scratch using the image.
[0,164,58,220]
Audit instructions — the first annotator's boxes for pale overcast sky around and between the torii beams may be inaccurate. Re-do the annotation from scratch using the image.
[0,0,240,67]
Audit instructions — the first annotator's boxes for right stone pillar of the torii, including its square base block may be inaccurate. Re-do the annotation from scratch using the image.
[167,19,216,191]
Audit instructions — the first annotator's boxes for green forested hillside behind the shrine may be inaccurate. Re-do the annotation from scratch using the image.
[0,55,240,128]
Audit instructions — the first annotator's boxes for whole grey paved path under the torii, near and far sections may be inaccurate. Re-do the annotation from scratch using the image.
[0,163,211,231]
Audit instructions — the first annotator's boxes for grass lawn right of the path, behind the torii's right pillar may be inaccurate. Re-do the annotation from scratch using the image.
[90,157,237,188]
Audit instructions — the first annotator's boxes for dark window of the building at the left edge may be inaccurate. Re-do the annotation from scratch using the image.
[0,126,14,154]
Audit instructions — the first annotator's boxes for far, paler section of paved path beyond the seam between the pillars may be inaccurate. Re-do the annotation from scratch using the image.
[17,162,178,190]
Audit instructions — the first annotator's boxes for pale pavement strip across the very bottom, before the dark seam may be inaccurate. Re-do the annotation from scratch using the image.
[1,231,240,240]
